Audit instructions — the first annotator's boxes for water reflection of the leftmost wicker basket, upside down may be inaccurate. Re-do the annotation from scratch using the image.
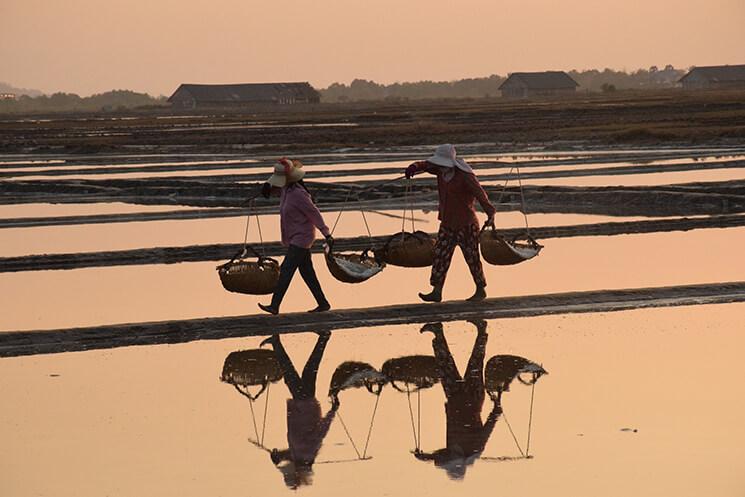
[220,349,283,400]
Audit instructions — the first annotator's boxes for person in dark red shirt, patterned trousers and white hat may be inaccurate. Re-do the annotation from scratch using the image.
[405,144,496,302]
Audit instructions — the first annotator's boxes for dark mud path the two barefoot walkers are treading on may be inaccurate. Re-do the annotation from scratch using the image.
[0,282,745,357]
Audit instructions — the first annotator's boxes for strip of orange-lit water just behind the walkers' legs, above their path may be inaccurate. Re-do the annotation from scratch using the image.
[0,229,745,332]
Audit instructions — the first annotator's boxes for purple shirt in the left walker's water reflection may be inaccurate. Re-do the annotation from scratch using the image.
[287,399,336,463]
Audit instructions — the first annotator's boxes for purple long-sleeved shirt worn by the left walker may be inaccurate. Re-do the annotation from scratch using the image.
[279,185,330,248]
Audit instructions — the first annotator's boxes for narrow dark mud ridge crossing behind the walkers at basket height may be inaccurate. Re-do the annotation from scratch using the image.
[0,215,745,273]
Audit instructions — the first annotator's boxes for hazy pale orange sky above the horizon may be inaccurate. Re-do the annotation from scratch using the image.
[0,0,745,95]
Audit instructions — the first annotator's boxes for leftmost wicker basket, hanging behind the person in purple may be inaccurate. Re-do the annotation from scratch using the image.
[217,246,279,295]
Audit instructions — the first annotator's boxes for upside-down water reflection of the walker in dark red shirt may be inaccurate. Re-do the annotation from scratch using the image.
[414,320,502,480]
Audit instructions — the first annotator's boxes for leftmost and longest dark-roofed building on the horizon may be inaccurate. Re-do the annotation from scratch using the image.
[168,83,321,109]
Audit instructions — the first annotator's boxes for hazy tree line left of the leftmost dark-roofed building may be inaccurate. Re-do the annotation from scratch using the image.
[0,90,165,113]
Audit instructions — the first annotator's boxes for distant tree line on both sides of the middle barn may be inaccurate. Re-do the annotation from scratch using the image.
[319,65,686,102]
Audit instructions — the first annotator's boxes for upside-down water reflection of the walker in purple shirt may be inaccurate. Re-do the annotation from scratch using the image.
[262,331,339,489]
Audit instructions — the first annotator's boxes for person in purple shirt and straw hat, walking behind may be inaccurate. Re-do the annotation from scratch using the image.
[259,158,333,314]
